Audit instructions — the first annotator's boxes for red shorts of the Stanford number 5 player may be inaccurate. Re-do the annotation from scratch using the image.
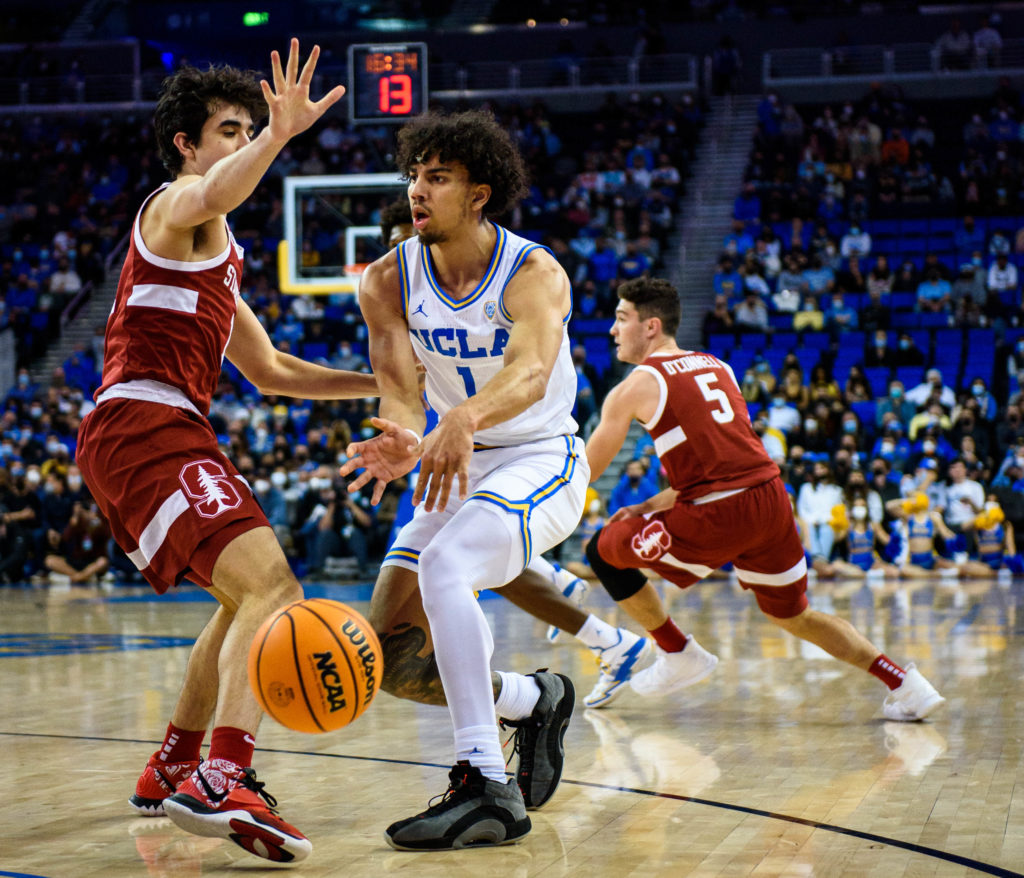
[598,478,807,619]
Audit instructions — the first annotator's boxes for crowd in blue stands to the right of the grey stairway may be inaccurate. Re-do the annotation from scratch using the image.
[702,79,1024,576]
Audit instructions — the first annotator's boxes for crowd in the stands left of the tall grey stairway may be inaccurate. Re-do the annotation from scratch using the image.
[0,87,703,582]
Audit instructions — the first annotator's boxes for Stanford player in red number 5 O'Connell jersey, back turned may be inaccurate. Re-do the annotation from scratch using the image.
[587,279,945,720]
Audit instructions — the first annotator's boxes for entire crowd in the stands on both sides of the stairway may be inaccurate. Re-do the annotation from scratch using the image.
[6,53,1024,582]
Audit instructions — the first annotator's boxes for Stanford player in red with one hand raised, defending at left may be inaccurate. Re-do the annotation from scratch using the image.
[78,39,377,861]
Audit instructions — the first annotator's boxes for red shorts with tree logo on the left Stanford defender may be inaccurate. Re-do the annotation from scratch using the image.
[76,400,269,594]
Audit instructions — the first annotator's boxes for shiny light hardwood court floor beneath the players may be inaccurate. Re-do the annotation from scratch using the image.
[0,580,1024,878]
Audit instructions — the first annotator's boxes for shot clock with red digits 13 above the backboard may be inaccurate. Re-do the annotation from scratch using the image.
[348,43,427,122]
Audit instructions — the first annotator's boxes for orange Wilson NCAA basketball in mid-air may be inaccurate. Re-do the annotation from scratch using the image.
[249,597,384,733]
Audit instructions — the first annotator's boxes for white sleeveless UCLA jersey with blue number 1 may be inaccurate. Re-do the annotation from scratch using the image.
[397,225,577,446]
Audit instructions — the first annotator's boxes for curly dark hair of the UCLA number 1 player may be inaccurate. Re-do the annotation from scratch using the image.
[396,110,527,216]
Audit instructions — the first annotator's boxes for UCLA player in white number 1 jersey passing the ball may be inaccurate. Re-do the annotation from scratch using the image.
[342,106,589,850]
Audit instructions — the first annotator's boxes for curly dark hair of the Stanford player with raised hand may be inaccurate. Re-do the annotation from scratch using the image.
[153,65,267,177]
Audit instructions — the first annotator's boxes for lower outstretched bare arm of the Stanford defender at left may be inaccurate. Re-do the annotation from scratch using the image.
[225,299,378,400]
